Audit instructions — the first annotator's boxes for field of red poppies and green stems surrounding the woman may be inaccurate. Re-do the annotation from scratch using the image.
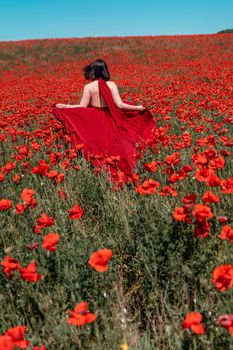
[0,34,233,350]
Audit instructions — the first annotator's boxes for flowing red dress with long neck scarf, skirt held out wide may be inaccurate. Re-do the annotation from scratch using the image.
[52,78,155,176]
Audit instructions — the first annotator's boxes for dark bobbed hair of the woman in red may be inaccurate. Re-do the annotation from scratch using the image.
[83,59,110,80]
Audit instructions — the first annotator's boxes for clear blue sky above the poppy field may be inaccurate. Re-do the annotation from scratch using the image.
[0,0,233,41]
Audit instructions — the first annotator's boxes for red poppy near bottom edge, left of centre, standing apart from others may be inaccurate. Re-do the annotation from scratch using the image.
[67,301,96,326]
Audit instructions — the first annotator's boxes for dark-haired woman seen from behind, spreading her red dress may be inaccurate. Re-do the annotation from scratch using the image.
[52,59,155,177]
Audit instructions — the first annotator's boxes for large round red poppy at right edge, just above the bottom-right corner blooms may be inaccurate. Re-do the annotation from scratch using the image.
[212,264,233,292]
